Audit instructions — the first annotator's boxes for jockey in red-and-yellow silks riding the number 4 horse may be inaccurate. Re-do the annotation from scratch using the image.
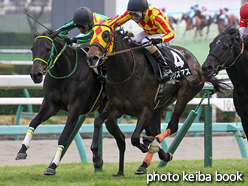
[116,0,175,80]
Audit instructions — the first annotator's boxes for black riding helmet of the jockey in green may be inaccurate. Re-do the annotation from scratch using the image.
[73,7,93,26]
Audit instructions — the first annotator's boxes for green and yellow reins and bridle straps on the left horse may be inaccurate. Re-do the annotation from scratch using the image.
[33,36,78,79]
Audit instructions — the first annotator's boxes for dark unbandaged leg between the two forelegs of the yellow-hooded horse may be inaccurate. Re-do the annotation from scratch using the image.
[105,120,126,177]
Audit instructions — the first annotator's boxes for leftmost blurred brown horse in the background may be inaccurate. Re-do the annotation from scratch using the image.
[181,13,212,38]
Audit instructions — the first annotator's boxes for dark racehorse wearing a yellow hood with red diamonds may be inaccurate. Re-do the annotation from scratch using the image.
[87,19,224,176]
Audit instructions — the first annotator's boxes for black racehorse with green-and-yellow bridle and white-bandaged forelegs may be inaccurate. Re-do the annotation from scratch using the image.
[16,32,121,175]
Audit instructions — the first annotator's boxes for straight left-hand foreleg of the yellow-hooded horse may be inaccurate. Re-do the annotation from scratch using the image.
[90,110,109,169]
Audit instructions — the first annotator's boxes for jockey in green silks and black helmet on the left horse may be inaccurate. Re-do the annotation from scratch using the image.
[56,7,108,83]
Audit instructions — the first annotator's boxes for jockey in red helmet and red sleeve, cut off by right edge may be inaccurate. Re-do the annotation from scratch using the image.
[239,2,248,39]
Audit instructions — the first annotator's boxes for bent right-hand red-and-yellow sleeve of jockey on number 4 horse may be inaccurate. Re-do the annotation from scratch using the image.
[155,15,175,42]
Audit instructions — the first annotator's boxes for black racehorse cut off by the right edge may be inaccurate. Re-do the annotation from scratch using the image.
[202,26,248,140]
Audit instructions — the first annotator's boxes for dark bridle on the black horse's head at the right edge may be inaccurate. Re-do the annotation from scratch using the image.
[209,32,244,74]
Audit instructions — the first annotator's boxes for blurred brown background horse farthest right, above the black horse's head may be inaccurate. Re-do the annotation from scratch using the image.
[216,14,239,33]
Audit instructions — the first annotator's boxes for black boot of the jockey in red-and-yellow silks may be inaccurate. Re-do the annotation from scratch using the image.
[152,49,172,80]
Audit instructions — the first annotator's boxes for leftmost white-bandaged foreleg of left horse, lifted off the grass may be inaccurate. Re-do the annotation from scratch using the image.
[16,100,58,160]
